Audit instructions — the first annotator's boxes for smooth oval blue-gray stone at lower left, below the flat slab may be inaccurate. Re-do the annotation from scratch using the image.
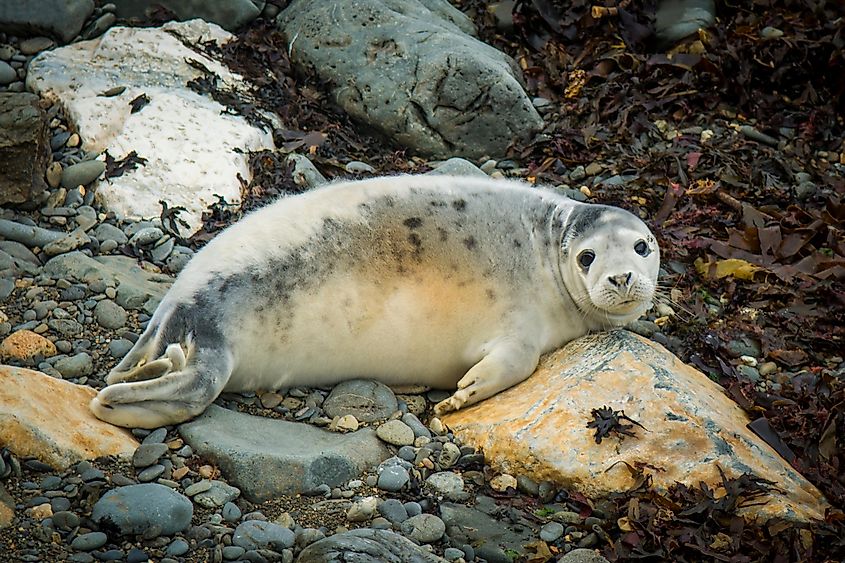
[91,483,194,535]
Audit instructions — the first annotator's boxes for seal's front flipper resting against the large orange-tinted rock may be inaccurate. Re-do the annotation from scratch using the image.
[434,341,540,416]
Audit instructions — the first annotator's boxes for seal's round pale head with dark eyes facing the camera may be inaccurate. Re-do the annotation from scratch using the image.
[560,205,660,326]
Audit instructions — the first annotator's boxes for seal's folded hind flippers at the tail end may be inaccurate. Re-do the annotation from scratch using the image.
[91,344,234,428]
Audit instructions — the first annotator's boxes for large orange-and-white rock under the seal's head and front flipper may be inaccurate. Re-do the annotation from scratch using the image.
[443,330,826,520]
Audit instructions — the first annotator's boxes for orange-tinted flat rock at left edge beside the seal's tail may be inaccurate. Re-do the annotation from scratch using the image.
[0,366,138,469]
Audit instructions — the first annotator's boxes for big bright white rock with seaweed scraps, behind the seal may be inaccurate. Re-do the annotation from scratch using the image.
[27,20,273,235]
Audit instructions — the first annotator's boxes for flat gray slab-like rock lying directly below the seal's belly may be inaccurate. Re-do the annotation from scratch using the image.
[179,405,390,502]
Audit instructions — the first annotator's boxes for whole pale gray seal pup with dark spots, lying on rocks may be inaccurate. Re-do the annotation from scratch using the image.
[91,176,660,428]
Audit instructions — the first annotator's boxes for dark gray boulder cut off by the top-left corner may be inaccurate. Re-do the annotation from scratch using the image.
[0,0,94,43]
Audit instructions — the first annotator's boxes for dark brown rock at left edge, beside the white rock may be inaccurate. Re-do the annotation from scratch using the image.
[0,93,50,204]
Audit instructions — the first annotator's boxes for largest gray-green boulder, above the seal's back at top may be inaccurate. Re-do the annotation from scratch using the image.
[277,0,543,158]
